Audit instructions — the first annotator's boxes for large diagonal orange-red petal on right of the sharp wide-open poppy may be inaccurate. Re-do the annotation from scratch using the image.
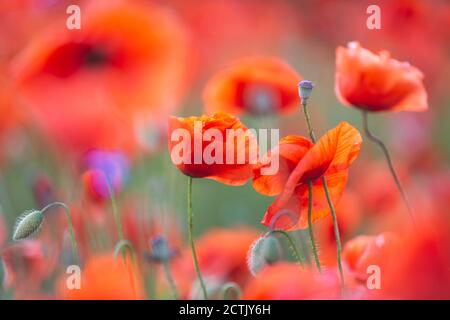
[262,122,362,229]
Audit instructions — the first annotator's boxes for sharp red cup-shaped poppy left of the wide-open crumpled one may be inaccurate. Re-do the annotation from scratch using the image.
[169,112,258,185]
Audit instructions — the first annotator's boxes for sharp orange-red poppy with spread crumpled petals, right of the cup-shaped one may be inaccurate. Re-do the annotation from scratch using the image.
[253,122,362,229]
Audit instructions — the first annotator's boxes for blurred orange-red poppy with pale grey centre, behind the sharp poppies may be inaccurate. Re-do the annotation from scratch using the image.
[203,57,301,115]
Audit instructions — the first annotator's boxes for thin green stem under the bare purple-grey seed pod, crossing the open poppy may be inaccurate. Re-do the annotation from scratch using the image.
[302,99,345,290]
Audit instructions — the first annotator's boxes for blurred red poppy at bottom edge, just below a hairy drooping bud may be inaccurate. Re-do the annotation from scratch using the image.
[243,262,340,300]
